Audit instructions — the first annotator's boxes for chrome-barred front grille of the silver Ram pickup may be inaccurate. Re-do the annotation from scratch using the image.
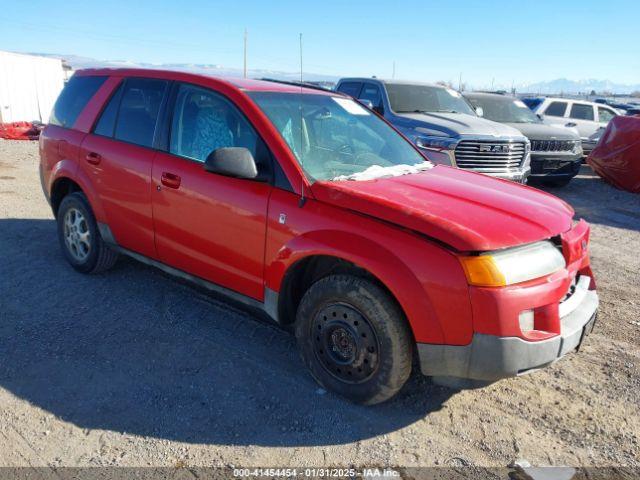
[455,140,526,173]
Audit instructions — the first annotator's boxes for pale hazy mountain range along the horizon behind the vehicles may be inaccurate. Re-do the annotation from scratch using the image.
[34,53,640,94]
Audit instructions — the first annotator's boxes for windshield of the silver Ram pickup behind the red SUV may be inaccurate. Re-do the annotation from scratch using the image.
[386,83,476,115]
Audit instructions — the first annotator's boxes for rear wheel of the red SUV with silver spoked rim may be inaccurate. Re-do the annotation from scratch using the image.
[57,192,118,273]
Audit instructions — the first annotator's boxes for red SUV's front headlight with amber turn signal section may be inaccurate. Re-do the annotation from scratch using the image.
[458,241,566,287]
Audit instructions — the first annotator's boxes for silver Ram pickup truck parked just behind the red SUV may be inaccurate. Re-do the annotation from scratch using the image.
[336,78,531,183]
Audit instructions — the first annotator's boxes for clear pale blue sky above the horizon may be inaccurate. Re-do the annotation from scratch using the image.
[0,0,640,87]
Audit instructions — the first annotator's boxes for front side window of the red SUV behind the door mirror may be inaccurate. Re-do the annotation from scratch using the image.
[169,84,267,168]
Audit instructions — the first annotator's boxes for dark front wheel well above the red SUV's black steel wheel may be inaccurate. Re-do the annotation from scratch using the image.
[278,255,395,325]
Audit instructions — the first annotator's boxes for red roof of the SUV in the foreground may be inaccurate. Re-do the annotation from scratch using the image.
[75,68,339,96]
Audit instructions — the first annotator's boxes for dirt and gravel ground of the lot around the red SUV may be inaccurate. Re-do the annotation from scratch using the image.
[0,140,640,467]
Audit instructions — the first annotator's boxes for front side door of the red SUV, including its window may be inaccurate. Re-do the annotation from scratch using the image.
[152,84,272,300]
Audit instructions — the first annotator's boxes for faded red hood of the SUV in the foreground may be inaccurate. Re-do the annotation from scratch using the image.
[312,165,574,251]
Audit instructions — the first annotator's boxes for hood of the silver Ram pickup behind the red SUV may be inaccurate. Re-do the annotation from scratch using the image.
[398,113,522,137]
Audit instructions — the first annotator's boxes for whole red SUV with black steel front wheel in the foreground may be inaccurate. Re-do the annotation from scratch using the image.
[40,69,598,404]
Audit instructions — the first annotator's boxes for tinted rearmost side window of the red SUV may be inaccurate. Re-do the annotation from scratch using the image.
[49,75,107,128]
